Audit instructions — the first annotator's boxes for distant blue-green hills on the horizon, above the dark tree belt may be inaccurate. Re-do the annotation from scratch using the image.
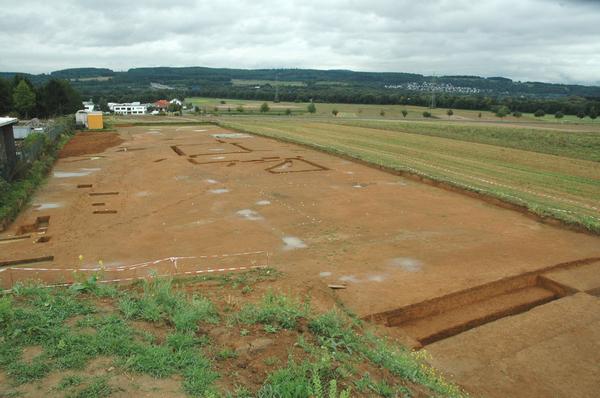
[0,67,600,98]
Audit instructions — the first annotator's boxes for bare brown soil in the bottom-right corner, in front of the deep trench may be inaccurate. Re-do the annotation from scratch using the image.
[427,293,600,398]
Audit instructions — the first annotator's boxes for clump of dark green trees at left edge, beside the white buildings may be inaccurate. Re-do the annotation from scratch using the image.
[0,75,82,119]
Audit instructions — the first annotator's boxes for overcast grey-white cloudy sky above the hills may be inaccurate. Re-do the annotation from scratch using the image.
[0,0,600,85]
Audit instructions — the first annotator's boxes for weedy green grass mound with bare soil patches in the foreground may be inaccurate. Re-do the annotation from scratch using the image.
[0,272,463,398]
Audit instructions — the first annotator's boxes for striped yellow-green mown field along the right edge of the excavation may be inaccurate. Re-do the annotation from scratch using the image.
[220,118,600,233]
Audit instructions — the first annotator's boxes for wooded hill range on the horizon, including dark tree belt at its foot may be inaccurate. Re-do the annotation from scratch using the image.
[0,67,600,117]
